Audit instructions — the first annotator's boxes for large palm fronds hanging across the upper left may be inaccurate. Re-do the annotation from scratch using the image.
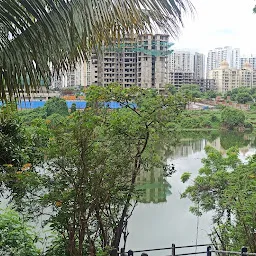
[0,0,193,100]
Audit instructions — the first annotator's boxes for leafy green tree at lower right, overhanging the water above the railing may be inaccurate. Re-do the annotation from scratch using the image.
[183,147,256,252]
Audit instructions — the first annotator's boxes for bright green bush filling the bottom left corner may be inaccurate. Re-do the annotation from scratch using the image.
[0,209,40,256]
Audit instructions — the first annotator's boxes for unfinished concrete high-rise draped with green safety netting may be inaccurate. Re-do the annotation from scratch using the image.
[87,34,172,90]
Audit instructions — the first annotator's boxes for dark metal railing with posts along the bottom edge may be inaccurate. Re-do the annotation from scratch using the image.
[109,244,256,256]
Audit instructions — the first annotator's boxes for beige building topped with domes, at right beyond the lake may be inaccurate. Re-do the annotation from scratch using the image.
[208,61,256,93]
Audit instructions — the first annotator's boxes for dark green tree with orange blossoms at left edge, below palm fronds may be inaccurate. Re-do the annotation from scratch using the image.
[0,105,49,209]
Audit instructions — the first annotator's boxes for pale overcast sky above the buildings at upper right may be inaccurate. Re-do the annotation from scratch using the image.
[173,0,256,55]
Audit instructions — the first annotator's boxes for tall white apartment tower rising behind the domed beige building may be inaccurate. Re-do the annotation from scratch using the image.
[206,46,240,74]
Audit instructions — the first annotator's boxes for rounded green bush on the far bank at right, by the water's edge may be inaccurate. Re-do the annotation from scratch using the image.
[221,107,245,129]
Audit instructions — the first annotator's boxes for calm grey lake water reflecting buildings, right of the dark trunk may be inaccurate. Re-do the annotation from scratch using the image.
[126,133,256,256]
